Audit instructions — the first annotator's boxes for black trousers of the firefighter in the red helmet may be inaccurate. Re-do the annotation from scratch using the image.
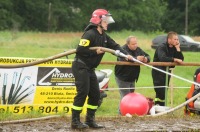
[72,61,100,107]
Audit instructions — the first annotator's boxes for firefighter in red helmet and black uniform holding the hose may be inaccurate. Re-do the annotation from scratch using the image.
[71,9,132,129]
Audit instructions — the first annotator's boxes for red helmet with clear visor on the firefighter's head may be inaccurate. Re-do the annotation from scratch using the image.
[90,9,115,24]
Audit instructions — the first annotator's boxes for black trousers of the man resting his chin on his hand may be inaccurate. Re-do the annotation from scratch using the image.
[152,70,171,106]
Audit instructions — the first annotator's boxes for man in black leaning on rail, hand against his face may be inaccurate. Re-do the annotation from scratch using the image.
[152,32,184,106]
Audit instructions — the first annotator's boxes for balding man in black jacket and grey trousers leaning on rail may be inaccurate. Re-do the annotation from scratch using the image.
[115,36,150,114]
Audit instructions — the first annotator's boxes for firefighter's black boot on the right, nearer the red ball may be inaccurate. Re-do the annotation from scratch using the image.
[85,110,104,129]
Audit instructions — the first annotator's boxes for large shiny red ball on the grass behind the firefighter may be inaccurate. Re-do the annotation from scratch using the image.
[120,93,149,115]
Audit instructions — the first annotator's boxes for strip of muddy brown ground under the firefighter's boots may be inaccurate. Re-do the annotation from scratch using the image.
[0,116,200,132]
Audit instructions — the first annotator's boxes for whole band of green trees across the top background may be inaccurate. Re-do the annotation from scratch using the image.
[0,0,200,35]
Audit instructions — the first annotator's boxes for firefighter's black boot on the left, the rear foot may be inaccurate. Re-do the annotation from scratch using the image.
[71,110,88,129]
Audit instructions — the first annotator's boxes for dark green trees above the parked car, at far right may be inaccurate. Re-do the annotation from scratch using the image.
[161,0,200,35]
